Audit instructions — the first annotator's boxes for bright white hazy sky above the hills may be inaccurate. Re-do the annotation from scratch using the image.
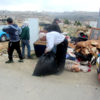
[0,0,100,12]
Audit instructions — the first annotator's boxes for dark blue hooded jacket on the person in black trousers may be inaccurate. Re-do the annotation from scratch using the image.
[3,24,21,42]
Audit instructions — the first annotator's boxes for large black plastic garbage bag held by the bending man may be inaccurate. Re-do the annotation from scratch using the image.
[33,52,57,76]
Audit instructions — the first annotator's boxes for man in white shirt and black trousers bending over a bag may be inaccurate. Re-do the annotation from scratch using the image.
[40,29,68,71]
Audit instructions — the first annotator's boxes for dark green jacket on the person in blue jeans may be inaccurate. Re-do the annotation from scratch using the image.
[21,26,30,40]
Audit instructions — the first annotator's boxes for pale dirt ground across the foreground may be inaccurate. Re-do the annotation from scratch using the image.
[0,54,100,100]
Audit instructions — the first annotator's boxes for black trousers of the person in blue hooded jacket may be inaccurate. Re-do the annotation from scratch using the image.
[8,41,22,60]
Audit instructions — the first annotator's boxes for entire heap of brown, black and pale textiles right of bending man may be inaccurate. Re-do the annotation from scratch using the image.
[65,40,100,72]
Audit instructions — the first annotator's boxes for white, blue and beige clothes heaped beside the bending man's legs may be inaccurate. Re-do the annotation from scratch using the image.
[65,48,91,72]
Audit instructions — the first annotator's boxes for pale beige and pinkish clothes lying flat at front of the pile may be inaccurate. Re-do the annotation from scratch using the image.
[65,60,91,72]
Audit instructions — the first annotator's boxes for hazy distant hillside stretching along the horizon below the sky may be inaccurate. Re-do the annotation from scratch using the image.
[0,11,99,21]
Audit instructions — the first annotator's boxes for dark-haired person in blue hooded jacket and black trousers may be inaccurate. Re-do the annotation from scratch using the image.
[3,18,23,63]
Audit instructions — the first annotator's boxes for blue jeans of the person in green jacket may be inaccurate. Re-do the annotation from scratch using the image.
[22,40,31,57]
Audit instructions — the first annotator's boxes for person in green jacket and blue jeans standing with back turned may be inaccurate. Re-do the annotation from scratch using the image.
[21,22,31,59]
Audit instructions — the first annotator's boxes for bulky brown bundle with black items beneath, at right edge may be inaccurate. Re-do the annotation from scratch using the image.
[75,40,100,66]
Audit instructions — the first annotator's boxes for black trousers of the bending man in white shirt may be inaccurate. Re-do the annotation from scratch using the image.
[56,39,68,69]
